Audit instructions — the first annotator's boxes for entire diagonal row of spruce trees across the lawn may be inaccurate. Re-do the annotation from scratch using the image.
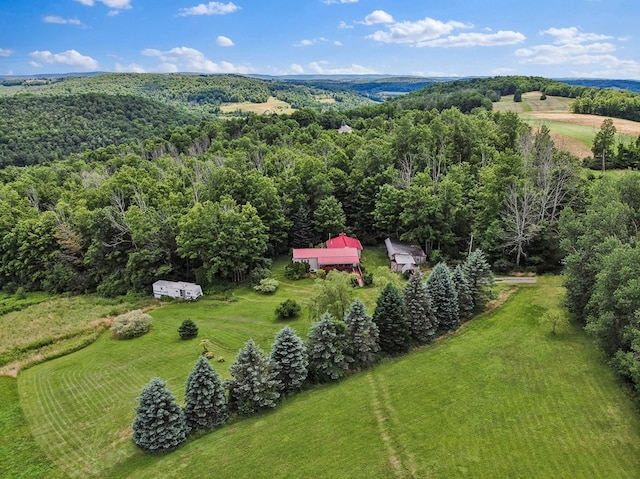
[133,250,492,453]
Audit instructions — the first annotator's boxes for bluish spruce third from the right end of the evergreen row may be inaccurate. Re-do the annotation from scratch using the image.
[427,263,460,331]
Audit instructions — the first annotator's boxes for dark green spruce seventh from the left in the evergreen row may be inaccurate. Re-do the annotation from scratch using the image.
[373,283,410,355]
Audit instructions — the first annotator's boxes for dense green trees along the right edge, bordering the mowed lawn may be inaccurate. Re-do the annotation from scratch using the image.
[559,172,640,392]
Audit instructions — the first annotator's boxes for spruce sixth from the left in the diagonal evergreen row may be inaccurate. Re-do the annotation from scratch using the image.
[344,299,380,369]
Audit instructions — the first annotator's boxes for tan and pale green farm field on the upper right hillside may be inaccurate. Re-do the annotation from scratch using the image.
[493,92,640,158]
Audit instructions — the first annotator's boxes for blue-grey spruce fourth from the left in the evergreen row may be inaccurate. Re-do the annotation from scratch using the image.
[271,326,309,394]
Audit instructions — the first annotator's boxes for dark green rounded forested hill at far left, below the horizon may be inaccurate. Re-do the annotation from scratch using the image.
[0,93,200,167]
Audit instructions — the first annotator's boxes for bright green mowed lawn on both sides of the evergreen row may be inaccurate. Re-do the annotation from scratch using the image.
[18,277,640,479]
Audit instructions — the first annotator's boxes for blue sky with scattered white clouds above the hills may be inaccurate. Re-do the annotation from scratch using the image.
[0,0,640,80]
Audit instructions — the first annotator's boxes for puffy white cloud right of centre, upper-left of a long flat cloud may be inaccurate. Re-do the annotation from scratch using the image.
[366,17,473,44]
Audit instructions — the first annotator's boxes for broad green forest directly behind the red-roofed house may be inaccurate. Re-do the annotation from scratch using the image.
[0,96,582,295]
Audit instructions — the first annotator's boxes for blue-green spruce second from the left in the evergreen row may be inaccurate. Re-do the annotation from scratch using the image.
[184,356,228,432]
